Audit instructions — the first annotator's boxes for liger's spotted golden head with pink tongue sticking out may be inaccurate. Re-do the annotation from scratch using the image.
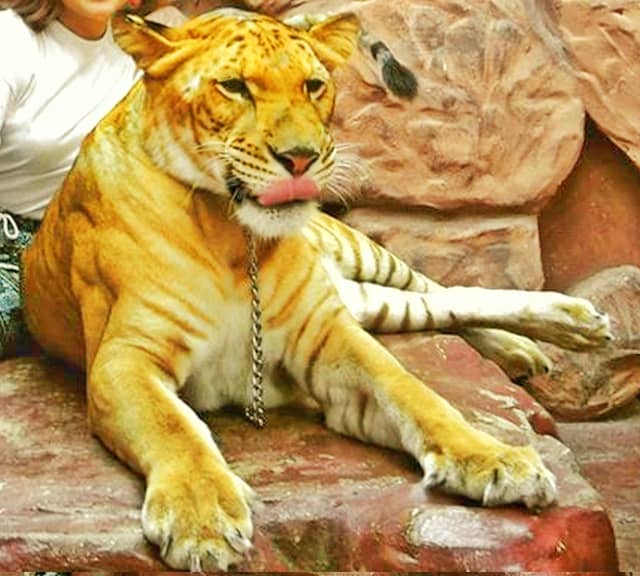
[117,10,359,237]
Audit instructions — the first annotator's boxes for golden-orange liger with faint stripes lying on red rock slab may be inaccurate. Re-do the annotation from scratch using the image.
[23,11,606,570]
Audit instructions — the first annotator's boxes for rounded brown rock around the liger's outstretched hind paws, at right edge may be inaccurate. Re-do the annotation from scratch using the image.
[527,266,640,420]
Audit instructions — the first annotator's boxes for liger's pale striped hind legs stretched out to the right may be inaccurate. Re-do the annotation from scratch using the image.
[305,214,610,377]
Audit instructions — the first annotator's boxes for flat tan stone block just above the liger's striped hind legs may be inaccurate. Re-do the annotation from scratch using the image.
[342,208,544,290]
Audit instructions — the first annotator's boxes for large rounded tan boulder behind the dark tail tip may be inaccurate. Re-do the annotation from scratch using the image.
[236,0,584,209]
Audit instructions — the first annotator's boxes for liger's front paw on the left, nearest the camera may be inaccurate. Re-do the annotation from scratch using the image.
[142,465,254,572]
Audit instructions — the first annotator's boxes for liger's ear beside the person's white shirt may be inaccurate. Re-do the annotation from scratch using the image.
[112,14,194,76]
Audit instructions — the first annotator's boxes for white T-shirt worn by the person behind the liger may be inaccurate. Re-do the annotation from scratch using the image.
[0,10,139,218]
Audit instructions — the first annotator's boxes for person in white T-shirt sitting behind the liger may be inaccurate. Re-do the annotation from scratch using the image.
[0,0,139,358]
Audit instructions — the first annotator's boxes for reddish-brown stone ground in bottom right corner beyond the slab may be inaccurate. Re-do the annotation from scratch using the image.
[558,401,640,574]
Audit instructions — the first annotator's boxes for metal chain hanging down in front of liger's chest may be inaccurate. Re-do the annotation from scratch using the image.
[244,230,267,428]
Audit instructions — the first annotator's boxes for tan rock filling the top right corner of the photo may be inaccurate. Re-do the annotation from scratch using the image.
[554,0,640,166]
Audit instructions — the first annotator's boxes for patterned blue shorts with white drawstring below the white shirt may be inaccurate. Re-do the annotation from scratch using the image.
[0,213,40,359]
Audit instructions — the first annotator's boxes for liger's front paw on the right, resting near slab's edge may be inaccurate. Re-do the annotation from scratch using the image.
[422,442,556,509]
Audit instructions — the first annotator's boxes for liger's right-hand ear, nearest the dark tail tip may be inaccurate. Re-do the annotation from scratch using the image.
[307,12,360,71]
